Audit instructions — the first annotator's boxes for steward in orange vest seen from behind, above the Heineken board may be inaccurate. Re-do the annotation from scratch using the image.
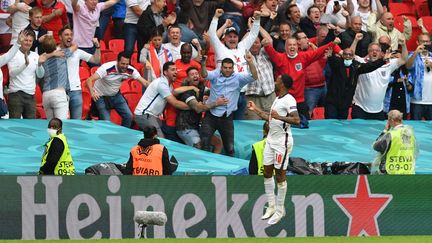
[125,126,174,176]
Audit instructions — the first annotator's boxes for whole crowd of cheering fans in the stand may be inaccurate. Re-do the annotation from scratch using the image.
[0,0,432,155]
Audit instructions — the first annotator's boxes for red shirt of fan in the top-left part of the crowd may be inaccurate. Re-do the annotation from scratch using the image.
[37,0,68,43]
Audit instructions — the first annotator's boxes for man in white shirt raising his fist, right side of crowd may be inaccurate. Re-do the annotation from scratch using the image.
[351,39,408,120]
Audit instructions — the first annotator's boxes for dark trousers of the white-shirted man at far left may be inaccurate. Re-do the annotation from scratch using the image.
[7,91,36,119]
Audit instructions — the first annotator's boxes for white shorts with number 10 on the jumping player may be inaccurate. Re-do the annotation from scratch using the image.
[263,143,292,170]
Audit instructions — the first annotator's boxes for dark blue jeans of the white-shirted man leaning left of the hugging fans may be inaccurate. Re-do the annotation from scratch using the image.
[96,92,132,128]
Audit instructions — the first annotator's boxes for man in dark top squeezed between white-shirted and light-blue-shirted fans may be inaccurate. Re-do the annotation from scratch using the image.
[176,66,228,148]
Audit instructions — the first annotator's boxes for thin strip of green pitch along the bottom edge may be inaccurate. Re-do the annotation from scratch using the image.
[0,236,432,243]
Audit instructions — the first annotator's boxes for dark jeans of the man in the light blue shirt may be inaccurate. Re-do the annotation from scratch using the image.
[200,112,234,157]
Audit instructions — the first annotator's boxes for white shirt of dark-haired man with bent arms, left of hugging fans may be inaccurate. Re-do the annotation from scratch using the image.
[94,61,141,96]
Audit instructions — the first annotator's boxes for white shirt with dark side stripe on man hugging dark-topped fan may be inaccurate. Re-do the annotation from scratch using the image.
[134,75,172,117]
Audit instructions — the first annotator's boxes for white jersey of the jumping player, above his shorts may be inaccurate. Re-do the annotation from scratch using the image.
[267,94,297,146]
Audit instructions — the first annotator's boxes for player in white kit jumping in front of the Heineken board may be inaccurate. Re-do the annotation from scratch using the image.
[248,74,300,224]
